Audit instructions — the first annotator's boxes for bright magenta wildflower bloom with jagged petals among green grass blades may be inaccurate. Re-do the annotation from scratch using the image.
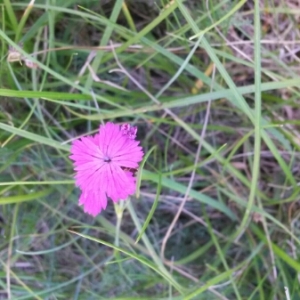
[70,122,143,217]
